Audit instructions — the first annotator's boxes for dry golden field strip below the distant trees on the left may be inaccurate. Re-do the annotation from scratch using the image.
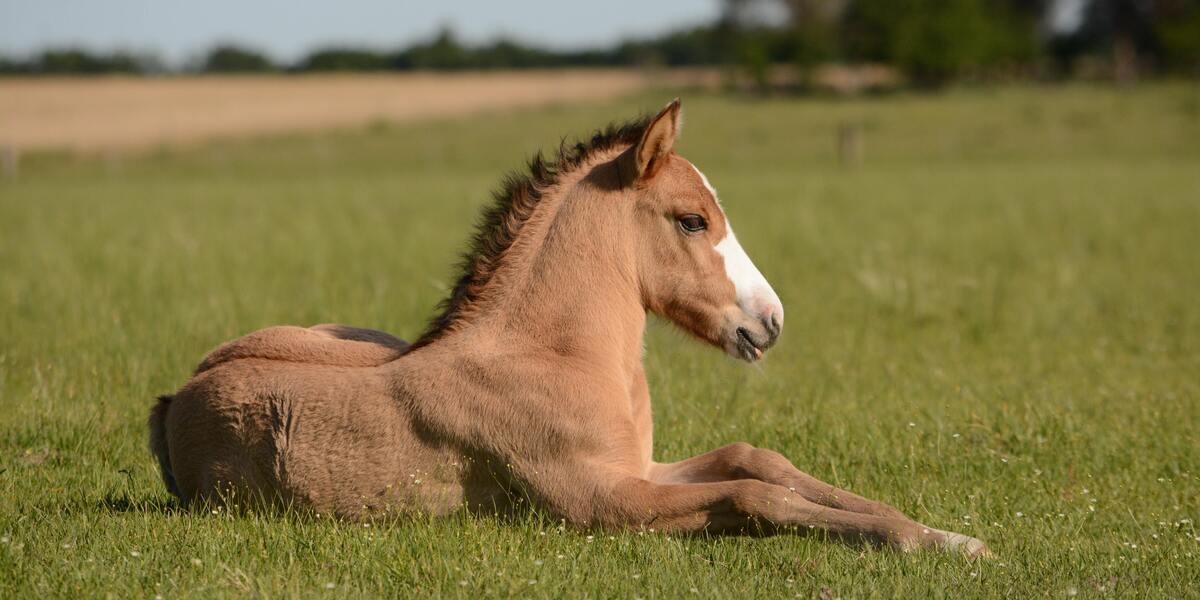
[0,70,710,152]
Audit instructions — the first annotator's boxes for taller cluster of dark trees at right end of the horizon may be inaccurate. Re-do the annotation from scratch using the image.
[726,0,1200,84]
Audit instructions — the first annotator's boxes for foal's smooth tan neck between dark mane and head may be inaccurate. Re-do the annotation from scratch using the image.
[453,158,646,380]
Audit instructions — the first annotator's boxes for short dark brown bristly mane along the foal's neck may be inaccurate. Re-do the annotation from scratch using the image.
[410,116,650,349]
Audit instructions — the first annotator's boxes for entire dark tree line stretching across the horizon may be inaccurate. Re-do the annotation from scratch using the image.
[0,0,1200,85]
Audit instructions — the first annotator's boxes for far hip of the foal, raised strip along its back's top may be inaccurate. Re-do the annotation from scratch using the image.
[196,323,409,374]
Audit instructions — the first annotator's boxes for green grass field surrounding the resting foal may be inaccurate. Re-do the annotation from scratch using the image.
[0,85,1200,599]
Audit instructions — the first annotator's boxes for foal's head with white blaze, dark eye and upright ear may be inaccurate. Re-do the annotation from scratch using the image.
[617,100,784,361]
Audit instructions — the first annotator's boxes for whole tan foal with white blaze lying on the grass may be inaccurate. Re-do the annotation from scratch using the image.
[150,101,988,556]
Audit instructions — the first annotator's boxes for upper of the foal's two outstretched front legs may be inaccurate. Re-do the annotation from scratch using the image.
[649,443,982,552]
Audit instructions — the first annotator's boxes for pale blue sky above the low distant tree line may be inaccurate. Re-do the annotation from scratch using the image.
[0,0,721,64]
